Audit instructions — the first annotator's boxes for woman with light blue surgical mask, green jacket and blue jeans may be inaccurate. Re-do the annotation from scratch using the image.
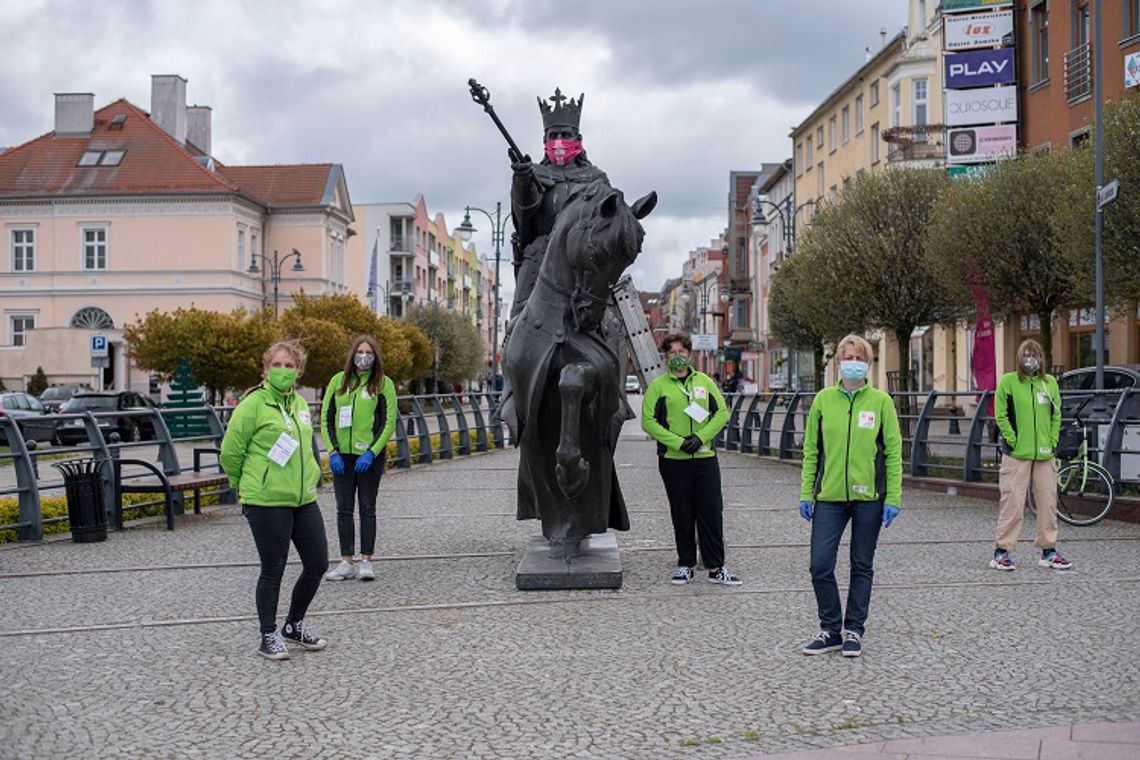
[799,335,903,657]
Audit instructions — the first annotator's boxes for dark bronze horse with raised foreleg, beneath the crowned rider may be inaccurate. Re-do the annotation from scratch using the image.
[503,180,657,557]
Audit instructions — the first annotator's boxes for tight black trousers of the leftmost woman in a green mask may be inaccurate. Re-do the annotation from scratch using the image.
[242,501,328,634]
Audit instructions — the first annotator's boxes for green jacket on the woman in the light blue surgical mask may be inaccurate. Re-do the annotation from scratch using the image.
[799,381,903,507]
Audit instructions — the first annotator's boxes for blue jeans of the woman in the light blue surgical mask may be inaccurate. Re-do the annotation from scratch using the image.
[812,501,882,636]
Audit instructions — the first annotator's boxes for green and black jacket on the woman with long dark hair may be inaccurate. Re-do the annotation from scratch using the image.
[320,370,398,461]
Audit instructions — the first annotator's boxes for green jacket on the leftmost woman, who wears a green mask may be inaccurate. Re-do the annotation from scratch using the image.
[220,383,320,507]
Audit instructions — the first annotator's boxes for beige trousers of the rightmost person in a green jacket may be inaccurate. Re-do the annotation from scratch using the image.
[996,456,1057,551]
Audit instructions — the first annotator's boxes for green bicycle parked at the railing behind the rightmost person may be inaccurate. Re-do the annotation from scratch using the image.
[1028,397,1116,526]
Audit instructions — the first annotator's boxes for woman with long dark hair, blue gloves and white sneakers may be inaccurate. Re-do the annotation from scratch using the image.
[320,335,397,581]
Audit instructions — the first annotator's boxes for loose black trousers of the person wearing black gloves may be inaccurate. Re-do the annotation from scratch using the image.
[657,457,724,567]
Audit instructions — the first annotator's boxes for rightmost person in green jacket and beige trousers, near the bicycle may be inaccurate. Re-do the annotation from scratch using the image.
[990,340,1073,571]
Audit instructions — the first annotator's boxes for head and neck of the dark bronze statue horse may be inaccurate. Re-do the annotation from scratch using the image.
[542,180,657,330]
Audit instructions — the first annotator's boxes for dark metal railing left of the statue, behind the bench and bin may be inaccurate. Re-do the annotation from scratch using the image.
[0,391,508,541]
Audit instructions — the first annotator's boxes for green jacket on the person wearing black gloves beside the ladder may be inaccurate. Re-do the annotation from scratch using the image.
[642,369,728,459]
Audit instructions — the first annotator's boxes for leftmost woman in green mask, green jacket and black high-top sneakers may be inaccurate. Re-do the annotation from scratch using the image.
[220,342,328,660]
